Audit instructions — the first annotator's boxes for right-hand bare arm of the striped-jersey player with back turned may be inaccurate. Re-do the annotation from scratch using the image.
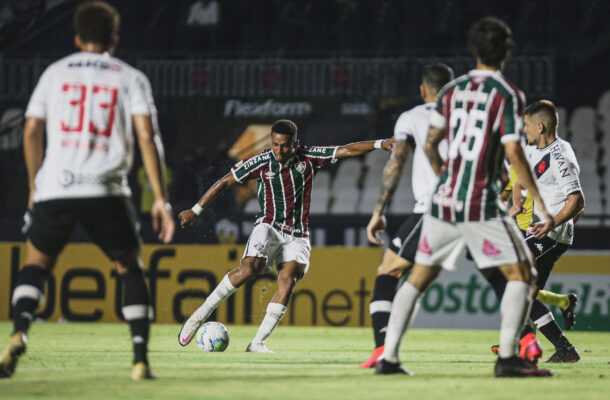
[504,141,555,239]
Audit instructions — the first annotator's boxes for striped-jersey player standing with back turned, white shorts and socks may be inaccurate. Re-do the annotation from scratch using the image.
[376,17,554,377]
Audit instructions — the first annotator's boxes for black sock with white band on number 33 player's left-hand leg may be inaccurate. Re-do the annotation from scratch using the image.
[12,265,49,333]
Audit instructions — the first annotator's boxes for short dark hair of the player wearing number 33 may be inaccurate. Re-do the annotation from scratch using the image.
[74,1,121,47]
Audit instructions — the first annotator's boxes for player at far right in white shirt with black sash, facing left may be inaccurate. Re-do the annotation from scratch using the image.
[486,100,585,363]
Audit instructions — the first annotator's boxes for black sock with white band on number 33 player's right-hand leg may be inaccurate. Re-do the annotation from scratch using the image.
[121,269,151,364]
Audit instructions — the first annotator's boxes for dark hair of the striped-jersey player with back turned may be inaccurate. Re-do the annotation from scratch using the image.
[468,17,515,67]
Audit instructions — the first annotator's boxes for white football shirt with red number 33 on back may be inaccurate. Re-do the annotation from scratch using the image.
[25,52,156,202]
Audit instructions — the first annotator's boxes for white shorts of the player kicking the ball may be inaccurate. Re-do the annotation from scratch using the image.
[241,224,311,275]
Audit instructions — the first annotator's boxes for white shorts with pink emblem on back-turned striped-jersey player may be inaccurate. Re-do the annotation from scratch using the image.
[415,214,534,270]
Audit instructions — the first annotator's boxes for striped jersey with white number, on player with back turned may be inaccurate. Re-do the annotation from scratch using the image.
[430,70,525,222]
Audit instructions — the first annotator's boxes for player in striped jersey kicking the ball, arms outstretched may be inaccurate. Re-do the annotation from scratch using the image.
[178,120,394,353]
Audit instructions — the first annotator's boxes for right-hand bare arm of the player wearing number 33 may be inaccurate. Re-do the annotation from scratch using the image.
[132,115,176,243]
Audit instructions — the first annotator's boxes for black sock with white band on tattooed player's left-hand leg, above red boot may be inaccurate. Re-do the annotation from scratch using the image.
[369,275,398,347]
